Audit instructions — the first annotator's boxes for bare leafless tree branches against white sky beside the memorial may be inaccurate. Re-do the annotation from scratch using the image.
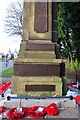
[5,1,23,37]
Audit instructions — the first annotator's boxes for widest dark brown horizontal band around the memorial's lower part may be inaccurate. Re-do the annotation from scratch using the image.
[14,63,65,76]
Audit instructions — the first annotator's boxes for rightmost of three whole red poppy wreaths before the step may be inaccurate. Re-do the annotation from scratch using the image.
[44,103,59,116]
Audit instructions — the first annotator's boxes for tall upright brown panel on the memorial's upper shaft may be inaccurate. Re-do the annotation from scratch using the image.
[34,2,48,33]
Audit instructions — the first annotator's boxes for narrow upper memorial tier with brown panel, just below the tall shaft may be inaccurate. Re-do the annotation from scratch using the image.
[20,40,55,52]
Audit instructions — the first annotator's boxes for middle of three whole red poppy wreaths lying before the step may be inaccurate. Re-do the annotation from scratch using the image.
[28,106,47,118]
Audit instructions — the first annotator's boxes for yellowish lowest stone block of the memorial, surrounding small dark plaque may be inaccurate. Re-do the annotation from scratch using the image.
[11,76,62,96]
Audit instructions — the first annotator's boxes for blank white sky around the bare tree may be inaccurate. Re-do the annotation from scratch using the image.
[0,0,21,54]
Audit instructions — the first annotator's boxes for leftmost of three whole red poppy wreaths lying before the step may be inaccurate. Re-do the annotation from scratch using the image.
[7,107,28,119]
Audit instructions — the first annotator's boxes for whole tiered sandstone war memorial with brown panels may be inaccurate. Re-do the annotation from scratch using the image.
[11,1,66,96]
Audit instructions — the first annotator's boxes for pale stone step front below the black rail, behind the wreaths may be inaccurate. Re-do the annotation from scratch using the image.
[4,99,77,108]
